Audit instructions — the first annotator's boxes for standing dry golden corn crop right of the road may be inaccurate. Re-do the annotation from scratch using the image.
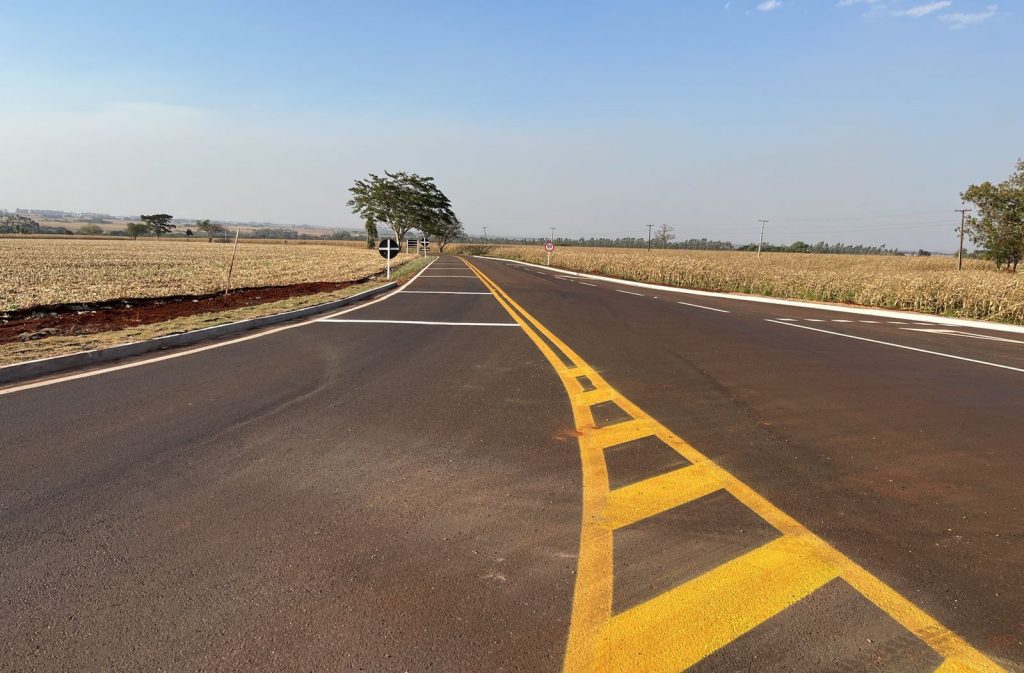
[450,246,1024,324]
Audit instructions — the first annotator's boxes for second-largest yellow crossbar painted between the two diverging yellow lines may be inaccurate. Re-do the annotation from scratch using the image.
[604,464,722,529]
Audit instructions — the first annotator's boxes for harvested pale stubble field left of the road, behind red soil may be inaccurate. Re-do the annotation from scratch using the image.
[0,238,413,310]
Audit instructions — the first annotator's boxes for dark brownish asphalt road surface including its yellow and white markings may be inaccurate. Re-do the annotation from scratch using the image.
[0,257,1024,672]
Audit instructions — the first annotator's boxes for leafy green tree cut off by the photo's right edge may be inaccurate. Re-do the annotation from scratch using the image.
[961,160,1024,271]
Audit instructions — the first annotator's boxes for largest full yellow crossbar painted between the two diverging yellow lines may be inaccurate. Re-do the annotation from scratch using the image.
[602,536,836,673]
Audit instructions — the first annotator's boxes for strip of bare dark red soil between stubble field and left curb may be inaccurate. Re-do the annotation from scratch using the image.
[0,279,367,343]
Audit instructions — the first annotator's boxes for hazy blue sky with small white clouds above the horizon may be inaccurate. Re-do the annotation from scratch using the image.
[0,0,1024,250]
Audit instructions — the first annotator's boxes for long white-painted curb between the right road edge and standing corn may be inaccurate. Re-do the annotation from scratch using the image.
[473,255,1024,334]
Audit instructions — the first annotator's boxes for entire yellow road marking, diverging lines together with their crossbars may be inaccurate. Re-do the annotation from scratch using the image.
[464,260,1005,673]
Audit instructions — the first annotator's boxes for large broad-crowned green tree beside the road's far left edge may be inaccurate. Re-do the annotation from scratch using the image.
[347,171,458,247]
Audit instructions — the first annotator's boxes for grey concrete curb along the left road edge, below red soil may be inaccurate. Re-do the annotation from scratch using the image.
[0,282,398,385]
